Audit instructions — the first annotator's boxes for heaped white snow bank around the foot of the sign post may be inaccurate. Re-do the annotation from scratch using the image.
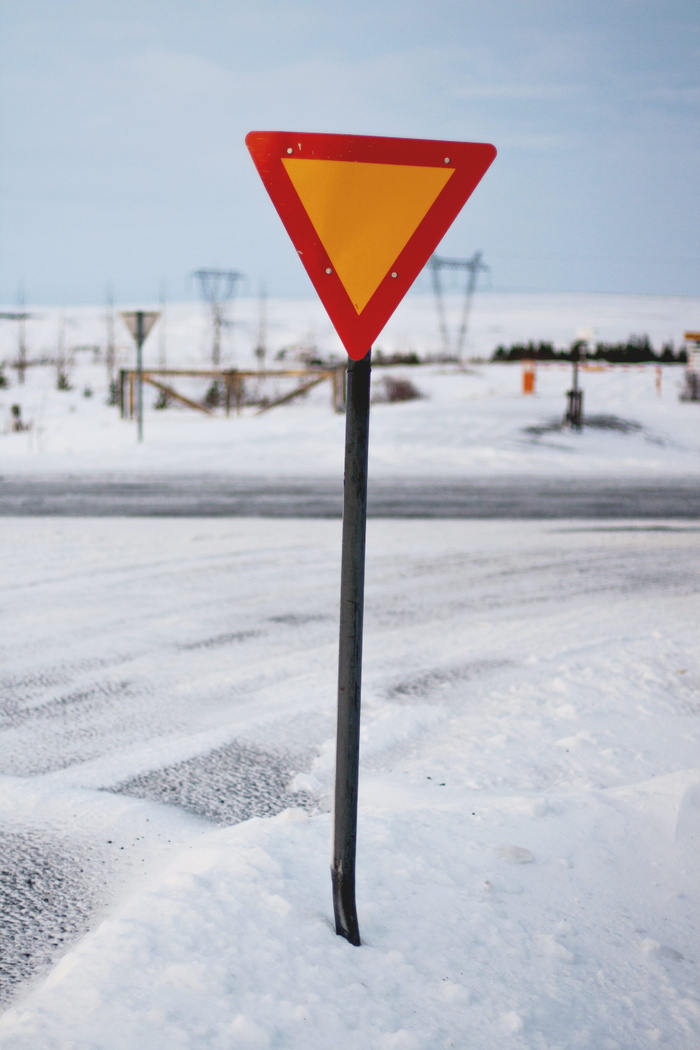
[0,771,700,1050]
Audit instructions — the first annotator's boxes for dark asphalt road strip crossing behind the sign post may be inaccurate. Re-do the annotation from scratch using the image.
[0,475,700,520]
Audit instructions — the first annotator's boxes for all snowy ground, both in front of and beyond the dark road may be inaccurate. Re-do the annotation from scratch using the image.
[0,294,700,1050]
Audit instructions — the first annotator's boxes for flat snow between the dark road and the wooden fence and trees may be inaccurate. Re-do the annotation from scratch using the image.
[5,356,700,478]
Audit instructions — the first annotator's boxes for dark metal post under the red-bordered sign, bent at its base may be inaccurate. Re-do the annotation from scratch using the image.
[331,351,372,945]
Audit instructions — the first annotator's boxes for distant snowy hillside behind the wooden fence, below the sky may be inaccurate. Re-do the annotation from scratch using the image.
[0,289,700,368]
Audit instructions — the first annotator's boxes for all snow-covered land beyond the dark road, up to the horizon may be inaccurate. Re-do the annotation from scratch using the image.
[0,294,700,478]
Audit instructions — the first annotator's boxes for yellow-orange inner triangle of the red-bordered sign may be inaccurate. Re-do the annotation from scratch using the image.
[282,158,454,314]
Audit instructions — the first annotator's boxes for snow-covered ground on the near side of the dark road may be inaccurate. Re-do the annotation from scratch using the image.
[0,519,700,1050]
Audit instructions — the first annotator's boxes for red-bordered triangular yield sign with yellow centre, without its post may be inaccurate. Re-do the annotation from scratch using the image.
[246,131,495,360]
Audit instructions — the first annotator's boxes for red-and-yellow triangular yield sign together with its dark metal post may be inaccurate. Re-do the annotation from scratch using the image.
[246,131,495,945]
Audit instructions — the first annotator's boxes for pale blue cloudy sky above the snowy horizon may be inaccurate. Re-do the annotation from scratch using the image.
[0,0,700,305]
